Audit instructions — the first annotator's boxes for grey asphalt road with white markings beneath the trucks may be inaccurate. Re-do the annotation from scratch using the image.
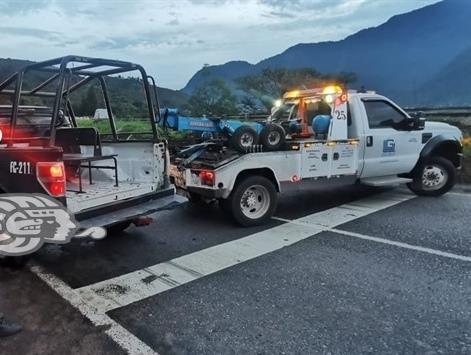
[0,186,471,354]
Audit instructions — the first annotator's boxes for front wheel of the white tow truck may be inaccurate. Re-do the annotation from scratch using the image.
[407,156,456,196]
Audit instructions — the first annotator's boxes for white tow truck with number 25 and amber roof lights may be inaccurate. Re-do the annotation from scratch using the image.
[171,86,462,226]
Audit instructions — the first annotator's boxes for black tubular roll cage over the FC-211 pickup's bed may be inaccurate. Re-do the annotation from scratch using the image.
[0,56,160,146]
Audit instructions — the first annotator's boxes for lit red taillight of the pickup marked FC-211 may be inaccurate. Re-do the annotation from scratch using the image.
[36,162,65,197]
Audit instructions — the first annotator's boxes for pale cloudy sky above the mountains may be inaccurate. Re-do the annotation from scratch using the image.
[0,0,438,89]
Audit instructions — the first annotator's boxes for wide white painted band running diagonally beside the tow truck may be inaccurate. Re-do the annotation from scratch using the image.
[75,191,414,314]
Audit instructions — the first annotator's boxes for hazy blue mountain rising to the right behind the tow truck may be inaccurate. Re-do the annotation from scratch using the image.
[183,0,471,105]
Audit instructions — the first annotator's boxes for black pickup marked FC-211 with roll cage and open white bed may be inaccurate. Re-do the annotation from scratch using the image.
[0,56,184,230]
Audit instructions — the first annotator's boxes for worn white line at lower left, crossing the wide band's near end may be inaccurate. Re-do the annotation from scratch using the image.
[31,265,158,355]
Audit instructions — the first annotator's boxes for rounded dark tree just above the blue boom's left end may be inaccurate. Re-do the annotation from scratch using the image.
[188,79,237,116]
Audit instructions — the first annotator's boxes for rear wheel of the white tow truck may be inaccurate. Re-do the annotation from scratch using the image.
[225,176,278,227]
